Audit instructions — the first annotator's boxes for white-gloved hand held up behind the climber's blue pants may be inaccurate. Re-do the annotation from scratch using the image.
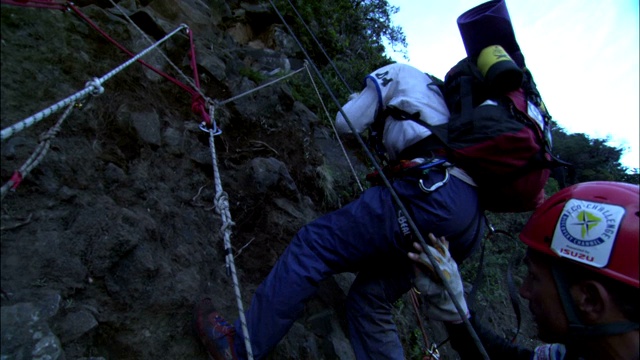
[408,234,469,323]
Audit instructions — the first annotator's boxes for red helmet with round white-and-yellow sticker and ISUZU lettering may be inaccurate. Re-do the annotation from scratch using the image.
[520,181,640,288]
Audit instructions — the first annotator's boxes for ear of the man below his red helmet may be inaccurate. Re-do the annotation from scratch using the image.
[572,280,613,324]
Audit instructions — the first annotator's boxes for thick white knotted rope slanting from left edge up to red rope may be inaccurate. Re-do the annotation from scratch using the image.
[0,24,188,140]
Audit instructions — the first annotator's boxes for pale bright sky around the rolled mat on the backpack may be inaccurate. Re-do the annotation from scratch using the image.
[389,0,640,168]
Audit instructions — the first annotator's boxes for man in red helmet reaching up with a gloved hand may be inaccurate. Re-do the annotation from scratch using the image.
[409,182,640,360]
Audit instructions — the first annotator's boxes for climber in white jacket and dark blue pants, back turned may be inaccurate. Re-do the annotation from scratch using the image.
[195,64,485,359]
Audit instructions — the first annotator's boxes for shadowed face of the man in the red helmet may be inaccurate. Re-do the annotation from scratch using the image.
[520,251,568,343]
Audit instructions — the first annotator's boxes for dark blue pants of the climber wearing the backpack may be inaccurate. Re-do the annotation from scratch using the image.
[235,170,484,359]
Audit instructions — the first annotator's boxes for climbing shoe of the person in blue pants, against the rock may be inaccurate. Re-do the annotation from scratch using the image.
[194,298,237,360]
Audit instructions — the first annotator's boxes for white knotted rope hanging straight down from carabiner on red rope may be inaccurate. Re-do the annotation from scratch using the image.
[209,106,253,360]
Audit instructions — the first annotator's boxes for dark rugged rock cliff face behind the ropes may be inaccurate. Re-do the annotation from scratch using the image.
[1,0,424,359]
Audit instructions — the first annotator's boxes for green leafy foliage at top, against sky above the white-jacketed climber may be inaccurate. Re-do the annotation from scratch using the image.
[274,0,407,116]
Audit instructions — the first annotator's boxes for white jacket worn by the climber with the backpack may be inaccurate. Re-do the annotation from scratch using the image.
[336,64,449,160]
